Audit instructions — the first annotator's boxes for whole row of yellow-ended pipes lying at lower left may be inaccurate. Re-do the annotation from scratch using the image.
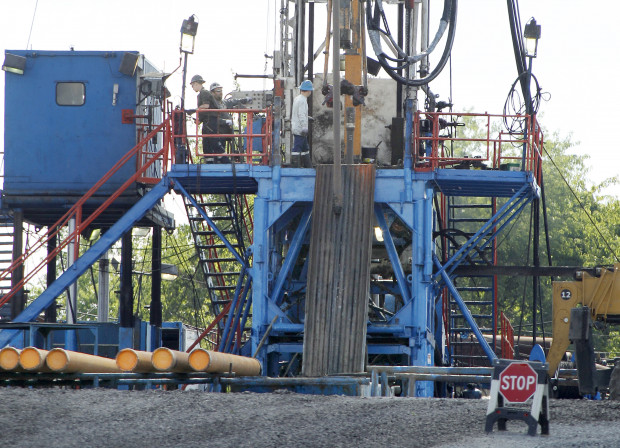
[0,347,261,376]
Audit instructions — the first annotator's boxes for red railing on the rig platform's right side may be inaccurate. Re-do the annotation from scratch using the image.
[412,112,544,184]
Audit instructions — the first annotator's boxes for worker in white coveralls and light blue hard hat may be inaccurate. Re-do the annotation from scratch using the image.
[291,80,314,168]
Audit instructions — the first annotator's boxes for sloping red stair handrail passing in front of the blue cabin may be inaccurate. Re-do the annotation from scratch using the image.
[0,120,170,312]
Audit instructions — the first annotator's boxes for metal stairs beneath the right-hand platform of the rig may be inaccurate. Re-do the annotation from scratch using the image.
[445,198,497,366]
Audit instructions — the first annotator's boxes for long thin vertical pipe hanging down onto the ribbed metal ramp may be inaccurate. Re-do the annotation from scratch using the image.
[332,0,343,215]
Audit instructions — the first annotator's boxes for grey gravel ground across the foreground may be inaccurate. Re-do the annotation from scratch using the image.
[0,388,620,448]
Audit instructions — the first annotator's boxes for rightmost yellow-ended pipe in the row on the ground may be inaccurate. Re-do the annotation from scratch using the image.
[189,348,261,376]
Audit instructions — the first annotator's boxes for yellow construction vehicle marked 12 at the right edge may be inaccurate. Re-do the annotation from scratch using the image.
[547,264,620,394]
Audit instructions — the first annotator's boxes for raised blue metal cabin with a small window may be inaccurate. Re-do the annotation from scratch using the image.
[3,50,171,226]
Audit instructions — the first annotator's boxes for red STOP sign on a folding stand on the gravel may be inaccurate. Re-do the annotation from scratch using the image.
[485,359,549,436]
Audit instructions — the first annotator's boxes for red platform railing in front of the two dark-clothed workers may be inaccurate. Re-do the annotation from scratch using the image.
[172,108,273,165]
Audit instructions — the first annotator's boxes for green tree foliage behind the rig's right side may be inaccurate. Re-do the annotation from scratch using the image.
[450,118,620,353]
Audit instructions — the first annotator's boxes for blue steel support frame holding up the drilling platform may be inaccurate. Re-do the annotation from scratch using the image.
[0,53,538,396]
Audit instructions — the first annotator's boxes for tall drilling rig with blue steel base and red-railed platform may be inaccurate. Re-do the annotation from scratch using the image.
[0,0,543,396]
